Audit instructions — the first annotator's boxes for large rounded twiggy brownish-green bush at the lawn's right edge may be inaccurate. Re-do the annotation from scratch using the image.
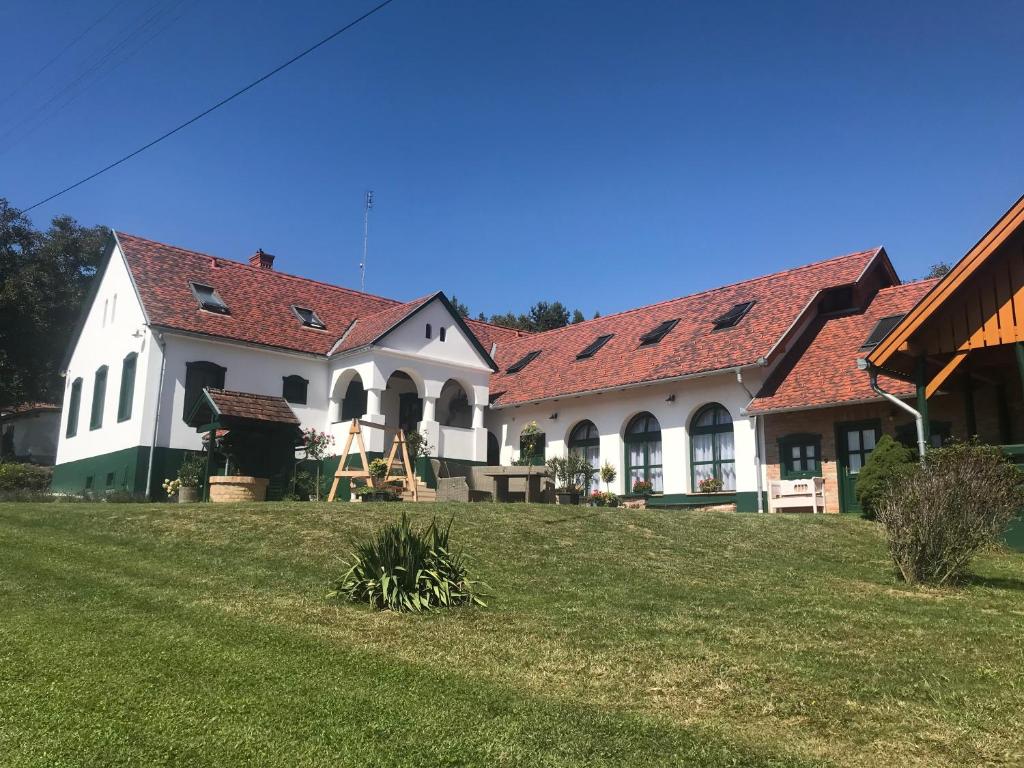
[877,441,1024,585]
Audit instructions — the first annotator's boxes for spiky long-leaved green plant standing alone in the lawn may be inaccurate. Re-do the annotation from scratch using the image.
[328,513,484,611]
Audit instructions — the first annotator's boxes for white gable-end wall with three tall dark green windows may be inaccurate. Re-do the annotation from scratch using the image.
[57,243,153,464]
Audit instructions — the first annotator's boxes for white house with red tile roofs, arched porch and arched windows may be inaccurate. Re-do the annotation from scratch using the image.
[53,232,905,511]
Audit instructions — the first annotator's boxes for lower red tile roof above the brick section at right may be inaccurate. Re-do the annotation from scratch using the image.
[749,280,937,413]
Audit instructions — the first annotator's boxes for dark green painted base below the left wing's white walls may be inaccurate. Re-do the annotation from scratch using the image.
[50,445,189,501]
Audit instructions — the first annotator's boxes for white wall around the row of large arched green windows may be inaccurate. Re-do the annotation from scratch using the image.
[486,371,763,494]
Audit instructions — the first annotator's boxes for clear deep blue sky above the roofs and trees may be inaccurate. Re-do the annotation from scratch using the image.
[0,0,1024,316]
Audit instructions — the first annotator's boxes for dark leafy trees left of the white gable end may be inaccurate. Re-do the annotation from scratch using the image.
[0,198,109,403]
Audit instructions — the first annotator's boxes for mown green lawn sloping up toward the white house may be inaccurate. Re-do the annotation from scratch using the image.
[0,504,1024,768]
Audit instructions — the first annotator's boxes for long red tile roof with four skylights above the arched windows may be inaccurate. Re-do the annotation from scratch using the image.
[490,248,888,406]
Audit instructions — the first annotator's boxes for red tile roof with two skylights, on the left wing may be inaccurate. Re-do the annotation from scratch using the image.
[117,232,398,354]
